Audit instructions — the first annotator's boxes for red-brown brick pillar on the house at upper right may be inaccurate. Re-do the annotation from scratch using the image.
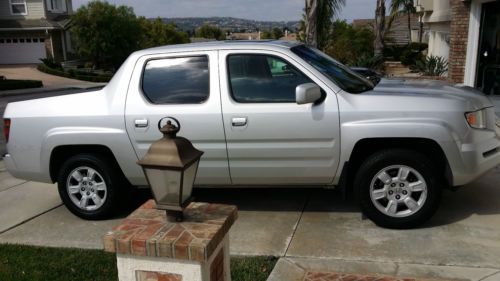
[448,0,470,83]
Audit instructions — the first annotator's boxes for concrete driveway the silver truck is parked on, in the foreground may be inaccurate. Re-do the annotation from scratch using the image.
[0,161,500,281]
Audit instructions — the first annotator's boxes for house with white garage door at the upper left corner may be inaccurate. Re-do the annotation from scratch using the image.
[0,0,73,64]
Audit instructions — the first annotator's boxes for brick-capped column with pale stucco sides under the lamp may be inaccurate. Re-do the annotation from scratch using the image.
[104,200,237,281]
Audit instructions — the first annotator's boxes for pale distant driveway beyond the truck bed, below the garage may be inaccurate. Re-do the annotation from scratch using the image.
[0,65,102,88]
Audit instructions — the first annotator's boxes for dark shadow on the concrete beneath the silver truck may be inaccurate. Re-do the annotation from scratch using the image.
[123,168,500,228]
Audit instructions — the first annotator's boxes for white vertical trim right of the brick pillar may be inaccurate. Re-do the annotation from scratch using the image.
[464,0,495,87]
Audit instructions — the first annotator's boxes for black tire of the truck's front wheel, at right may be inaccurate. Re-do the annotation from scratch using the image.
[354,149,444,229]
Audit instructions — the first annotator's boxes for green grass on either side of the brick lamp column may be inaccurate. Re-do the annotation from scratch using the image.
[0,244,277,281]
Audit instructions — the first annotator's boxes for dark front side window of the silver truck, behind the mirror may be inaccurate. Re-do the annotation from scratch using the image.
[227,54,312,103]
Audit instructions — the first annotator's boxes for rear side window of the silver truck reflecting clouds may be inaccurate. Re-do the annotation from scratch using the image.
[142,56,209,104]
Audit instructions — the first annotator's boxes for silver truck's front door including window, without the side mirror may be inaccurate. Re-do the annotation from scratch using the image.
[219,50,339,185]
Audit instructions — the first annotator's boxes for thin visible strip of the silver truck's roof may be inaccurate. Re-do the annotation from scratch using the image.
[133,40,302,54]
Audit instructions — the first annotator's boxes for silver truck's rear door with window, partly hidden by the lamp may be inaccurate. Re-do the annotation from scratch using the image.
[125,51,230,185]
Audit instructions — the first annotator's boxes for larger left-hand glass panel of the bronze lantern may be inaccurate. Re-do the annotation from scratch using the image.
[145,168,181,206]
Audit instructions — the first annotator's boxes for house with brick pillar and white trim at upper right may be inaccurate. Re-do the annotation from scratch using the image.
[415,0,500,96]
